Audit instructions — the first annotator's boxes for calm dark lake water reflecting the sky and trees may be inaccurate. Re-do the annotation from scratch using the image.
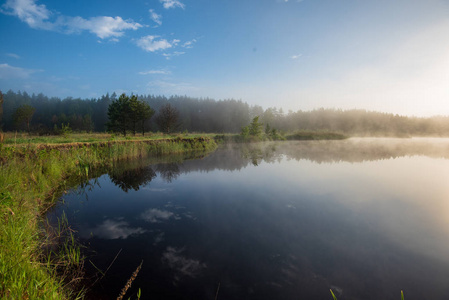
[50,139,449,300]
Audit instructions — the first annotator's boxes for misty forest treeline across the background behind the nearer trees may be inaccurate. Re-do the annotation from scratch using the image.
[0,90,449,137]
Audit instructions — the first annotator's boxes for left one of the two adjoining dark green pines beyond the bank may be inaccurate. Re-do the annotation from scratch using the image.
[106,93,132,136]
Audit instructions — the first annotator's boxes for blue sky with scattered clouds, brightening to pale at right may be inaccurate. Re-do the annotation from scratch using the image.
[0,0,449,117]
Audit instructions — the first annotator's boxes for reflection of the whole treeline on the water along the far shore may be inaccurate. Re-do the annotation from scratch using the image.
[109,138,449,192]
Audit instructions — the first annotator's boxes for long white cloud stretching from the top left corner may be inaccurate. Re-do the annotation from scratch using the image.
[2,0,143,41]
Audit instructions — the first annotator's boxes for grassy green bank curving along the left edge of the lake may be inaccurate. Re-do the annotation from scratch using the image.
[0,136,216,299]
